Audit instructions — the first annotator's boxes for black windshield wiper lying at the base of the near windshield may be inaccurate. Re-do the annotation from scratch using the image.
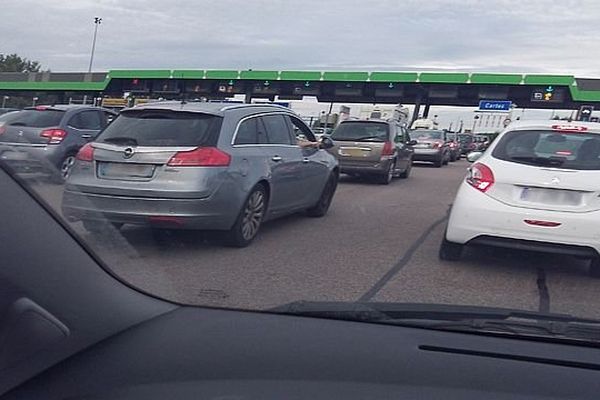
[268,301,600,341]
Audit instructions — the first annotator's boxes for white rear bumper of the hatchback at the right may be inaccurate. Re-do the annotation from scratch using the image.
[446,182,600,257]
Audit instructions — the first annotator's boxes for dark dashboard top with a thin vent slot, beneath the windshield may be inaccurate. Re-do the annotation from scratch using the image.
[7,307,600,399]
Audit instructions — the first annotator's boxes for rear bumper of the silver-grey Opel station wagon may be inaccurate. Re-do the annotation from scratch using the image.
[62,190,239,230]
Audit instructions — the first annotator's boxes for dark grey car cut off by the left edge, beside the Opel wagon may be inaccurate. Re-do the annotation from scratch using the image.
[0,104,116,181]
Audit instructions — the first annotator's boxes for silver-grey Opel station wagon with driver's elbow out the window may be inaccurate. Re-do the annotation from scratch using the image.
[63,102,339,247]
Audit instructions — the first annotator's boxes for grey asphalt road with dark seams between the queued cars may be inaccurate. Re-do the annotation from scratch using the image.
[30,161,600,318]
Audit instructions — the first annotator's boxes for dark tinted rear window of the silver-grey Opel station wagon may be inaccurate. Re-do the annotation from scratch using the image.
[97,110,222,146]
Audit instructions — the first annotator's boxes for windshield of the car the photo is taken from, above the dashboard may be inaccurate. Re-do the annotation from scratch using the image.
[0,0,600,350]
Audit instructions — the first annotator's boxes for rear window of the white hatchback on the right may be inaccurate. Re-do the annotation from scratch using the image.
[492,130,600,170]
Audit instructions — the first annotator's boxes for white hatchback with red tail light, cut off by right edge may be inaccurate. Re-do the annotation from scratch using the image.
[439,121,600,275]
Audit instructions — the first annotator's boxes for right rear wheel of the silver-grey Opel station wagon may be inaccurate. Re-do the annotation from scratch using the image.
[226,184,268,247]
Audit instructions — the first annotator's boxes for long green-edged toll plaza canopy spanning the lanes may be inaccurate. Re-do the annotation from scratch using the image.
[0,70,600,109]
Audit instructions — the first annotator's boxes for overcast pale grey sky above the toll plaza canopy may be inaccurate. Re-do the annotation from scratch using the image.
[0,0,600,77]
